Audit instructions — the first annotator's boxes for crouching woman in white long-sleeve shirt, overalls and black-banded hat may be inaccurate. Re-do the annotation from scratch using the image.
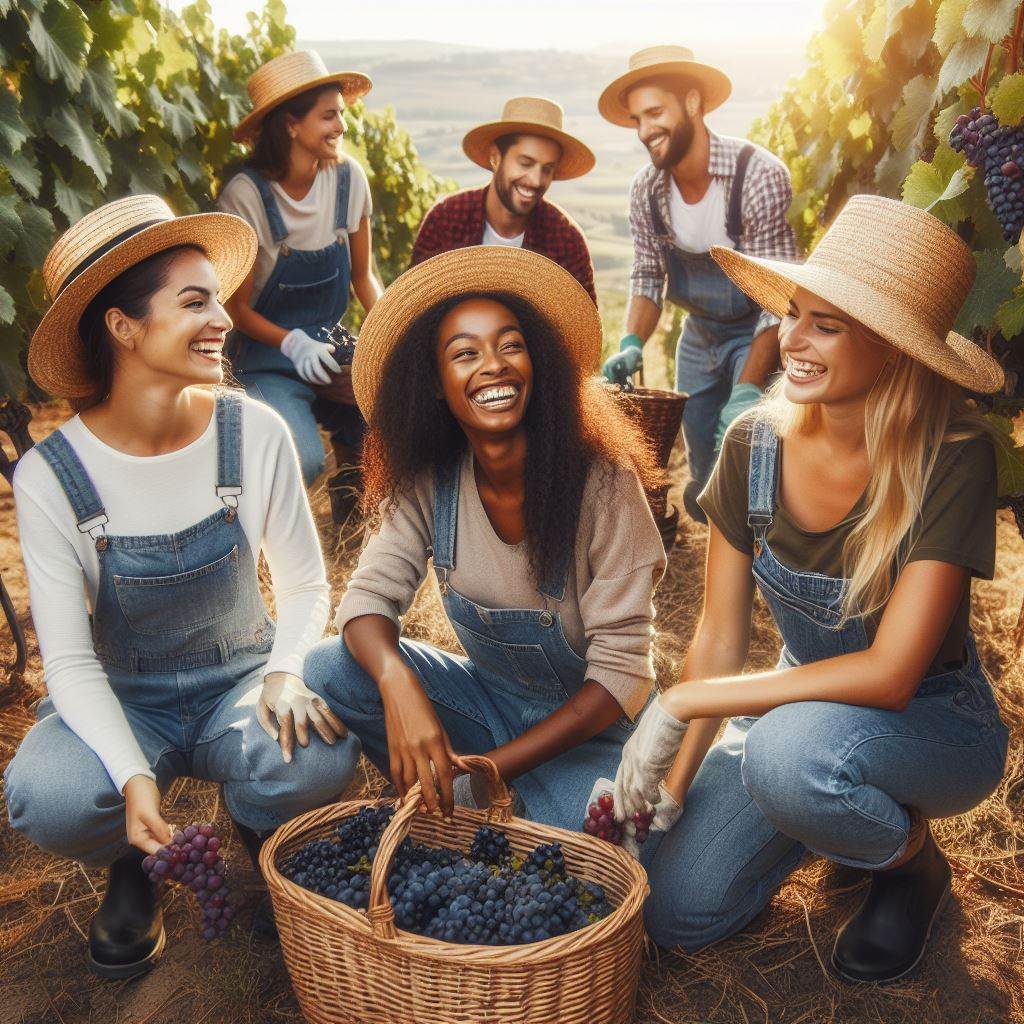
[4,196,352,978]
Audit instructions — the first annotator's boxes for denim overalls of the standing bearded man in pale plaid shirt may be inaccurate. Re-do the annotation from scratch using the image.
[649,146,761,484]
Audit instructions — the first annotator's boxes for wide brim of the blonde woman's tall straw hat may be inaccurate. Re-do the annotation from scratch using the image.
[711,246,1005,394]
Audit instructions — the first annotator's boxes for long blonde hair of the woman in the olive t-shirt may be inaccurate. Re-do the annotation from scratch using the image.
[759,352,997,621]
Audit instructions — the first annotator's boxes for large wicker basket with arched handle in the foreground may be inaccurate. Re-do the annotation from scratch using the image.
[260,757,648,1024]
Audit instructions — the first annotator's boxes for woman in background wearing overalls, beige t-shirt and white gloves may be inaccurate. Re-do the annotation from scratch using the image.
[218,50,381,509]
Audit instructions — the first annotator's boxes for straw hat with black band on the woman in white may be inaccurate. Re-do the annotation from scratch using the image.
[29,196,256,398]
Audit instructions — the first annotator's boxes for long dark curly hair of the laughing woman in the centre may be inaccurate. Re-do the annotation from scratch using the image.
[362,292,663,583]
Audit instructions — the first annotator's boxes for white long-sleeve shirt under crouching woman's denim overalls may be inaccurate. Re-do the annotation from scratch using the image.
[14,399,330,791]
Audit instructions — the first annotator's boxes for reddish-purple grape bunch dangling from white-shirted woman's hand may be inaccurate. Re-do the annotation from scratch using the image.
[142,824,240,939]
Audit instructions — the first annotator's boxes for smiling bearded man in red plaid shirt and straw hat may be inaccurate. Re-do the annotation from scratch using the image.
[412,96,597,303]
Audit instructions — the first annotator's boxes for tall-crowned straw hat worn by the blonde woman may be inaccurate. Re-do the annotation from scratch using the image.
[711,196,1004,393]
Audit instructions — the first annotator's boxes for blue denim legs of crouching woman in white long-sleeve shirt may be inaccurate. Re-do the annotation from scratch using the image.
[4,653,358,867]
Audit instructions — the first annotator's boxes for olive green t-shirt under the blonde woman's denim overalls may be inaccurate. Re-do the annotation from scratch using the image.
[697,418,996,671]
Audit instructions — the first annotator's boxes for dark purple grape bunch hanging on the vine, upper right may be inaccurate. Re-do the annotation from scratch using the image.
[949,106,1024,245]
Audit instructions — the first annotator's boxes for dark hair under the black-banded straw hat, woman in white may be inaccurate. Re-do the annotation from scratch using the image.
[72,245,206,412]
